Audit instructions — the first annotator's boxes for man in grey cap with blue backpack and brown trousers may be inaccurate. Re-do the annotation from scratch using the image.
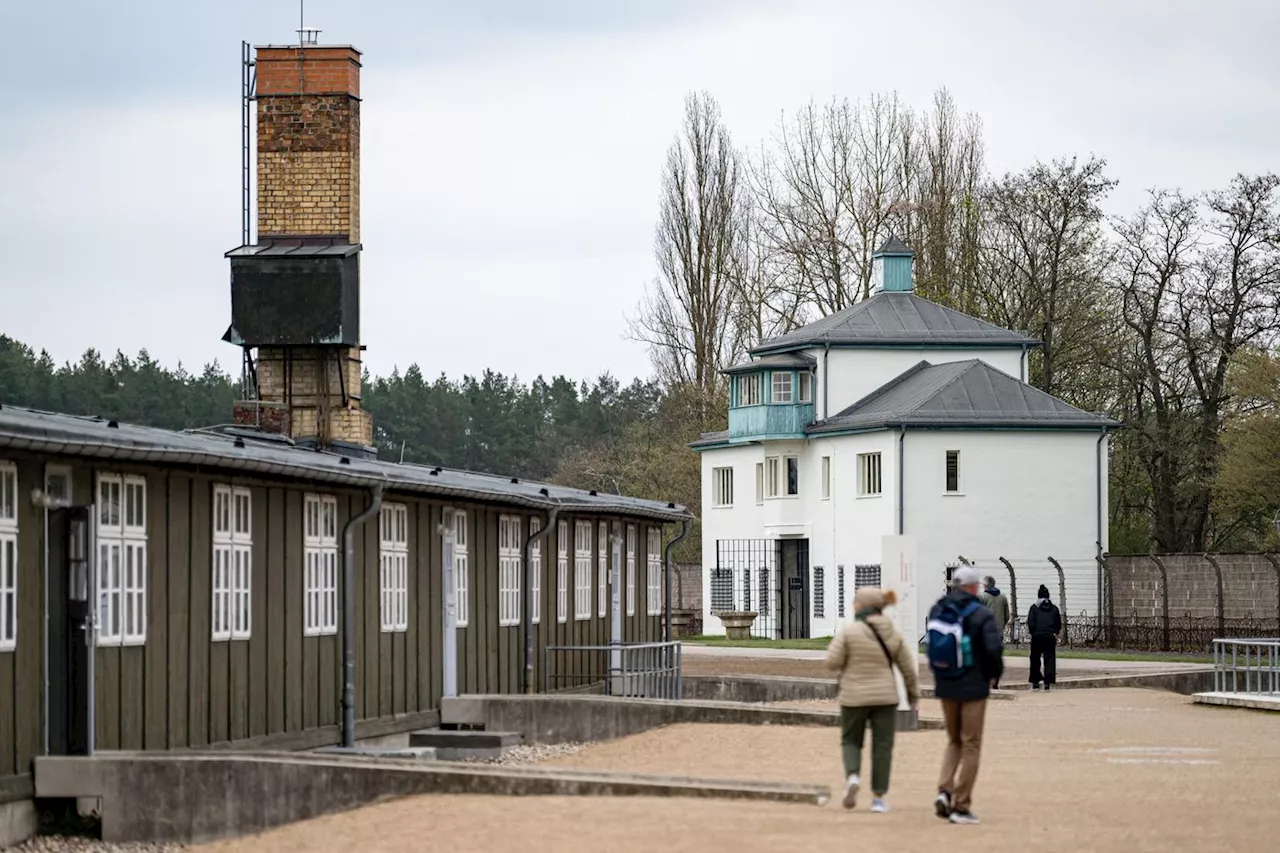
[925,566,1005,824]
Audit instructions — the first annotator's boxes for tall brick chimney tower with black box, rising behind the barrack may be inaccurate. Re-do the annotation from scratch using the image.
[224,33,374,456]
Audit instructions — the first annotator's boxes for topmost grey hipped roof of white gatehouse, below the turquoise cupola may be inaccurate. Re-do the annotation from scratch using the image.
[751,292,1039,355]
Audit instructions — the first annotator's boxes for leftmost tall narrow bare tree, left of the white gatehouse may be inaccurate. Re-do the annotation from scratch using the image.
[631,92,745,416]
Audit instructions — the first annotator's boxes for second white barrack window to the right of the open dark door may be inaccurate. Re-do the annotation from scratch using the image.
[210,483,253,643]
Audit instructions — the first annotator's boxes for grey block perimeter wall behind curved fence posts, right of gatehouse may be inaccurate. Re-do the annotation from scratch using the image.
[1107,553,1280,621]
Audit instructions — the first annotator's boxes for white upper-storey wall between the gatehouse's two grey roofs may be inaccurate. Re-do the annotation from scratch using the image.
[808,347,1024,419]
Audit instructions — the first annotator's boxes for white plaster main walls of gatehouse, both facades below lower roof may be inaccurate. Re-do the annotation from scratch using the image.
[701,430,1107,637]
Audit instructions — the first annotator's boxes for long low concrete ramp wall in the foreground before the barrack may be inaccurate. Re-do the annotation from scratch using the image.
[36,753,831,844]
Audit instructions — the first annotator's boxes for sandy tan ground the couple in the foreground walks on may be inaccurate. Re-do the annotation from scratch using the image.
[200,689,1280,853]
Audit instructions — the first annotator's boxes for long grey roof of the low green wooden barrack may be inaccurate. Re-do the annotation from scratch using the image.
[0,406,691,521]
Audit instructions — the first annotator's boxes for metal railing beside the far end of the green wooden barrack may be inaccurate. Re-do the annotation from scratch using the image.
[543,642,684,699]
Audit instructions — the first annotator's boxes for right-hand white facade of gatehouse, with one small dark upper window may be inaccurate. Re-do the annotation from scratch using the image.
[904,430,1107,620]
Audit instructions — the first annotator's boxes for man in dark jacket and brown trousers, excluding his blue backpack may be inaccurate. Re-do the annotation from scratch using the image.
[929,566,1005,824]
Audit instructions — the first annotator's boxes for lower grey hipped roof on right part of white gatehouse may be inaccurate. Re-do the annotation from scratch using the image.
[805,359,1121,433]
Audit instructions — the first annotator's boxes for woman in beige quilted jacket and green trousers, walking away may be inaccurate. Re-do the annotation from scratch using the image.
[827,588,920,812]
